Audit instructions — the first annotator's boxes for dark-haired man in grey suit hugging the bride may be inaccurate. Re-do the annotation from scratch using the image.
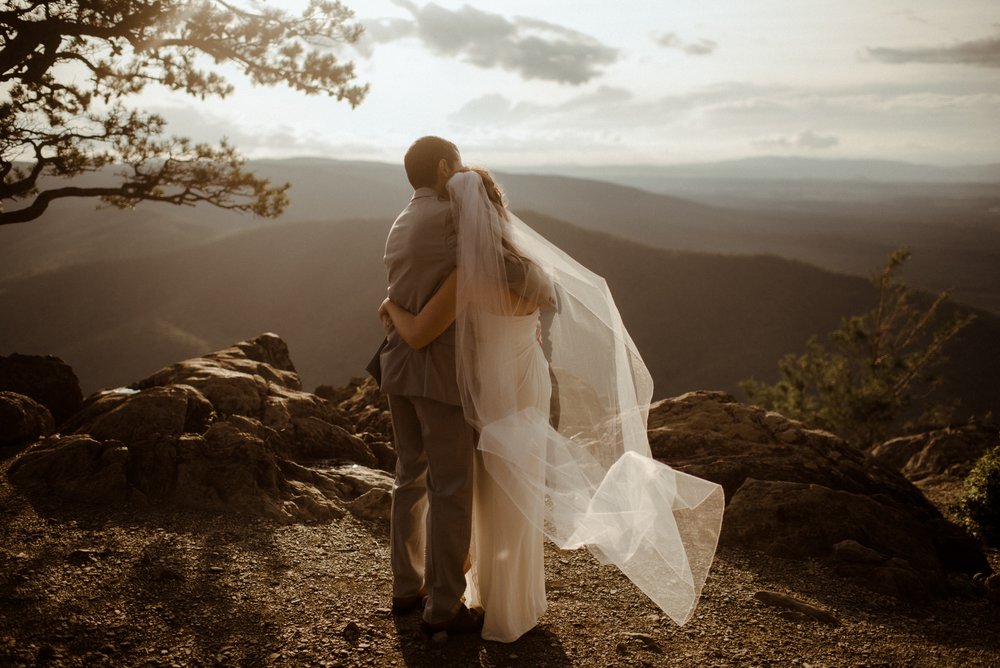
[381,137,483,633]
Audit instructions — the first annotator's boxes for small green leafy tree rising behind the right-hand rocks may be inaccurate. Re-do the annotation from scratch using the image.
[740,248,975,447]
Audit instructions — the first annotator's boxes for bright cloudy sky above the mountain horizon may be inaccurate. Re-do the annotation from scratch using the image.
[143,0,1000,168]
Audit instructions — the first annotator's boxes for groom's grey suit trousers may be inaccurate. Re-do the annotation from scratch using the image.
[389,395,475,623]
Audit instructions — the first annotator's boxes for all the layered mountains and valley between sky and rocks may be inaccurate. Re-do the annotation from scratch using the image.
[0,160,1000,413]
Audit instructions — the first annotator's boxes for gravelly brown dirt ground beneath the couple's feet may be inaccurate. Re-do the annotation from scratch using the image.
[0,457,1000,668]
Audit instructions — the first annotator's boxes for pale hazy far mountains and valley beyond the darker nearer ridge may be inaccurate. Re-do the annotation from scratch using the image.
[9,158,1000,313]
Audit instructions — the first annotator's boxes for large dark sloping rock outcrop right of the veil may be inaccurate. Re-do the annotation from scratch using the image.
[649,392,990,598]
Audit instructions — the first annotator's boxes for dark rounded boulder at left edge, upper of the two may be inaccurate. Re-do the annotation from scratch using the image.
[0,353,83,426]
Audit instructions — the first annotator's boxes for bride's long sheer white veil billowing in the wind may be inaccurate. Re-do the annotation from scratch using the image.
[448,172,724,640]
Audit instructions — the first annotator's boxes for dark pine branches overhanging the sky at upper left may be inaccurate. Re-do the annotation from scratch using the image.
[0,0,368,224]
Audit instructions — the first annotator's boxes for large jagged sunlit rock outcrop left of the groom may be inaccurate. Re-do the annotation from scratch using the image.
[8,334,391,521]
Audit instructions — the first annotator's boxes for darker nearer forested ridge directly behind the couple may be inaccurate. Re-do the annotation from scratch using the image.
[0,212,1000,414]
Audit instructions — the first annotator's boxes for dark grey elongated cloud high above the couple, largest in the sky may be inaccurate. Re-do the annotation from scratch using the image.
[360,0,618,85]
